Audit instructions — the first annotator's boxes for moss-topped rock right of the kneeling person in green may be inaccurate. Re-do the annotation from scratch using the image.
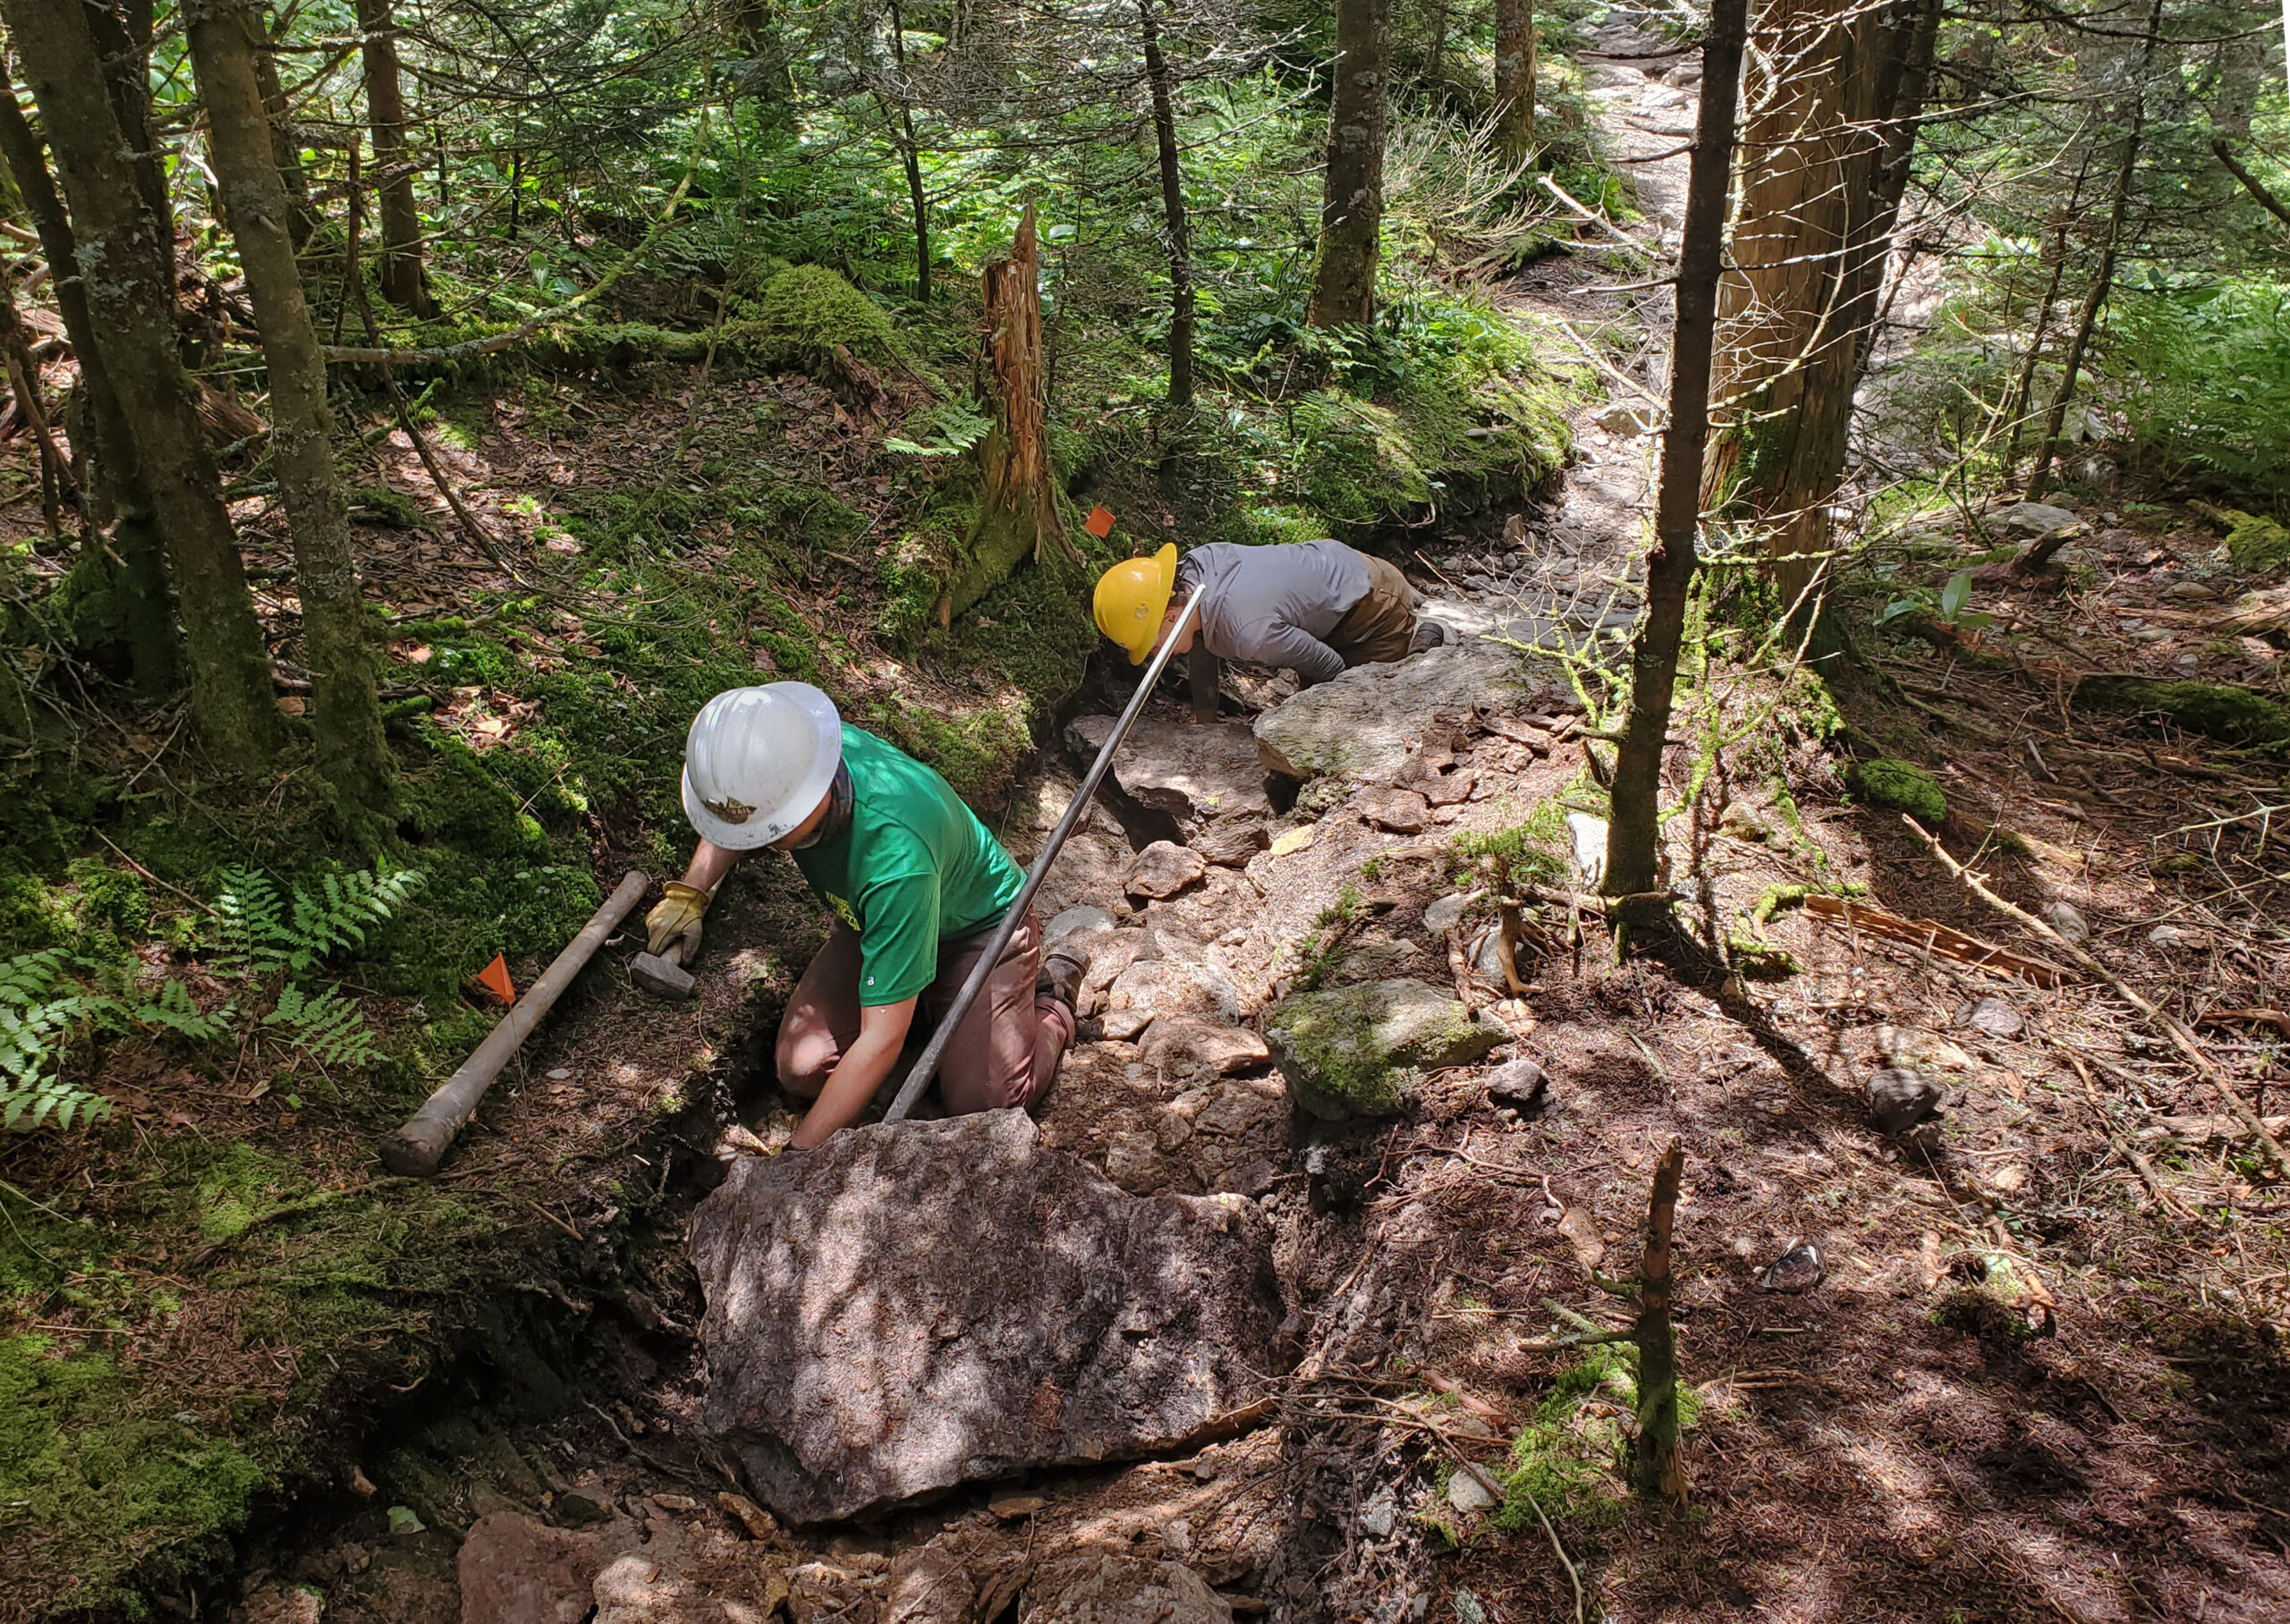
[1264,980,1505,1122]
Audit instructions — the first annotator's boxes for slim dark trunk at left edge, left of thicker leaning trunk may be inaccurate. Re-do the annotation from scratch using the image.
[0,80,183,698]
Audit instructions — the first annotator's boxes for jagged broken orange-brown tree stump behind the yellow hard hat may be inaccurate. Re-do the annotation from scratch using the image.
[939,204,1081,625]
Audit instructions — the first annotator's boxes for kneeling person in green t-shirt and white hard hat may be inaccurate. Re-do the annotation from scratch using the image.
[643,682,1088,1150]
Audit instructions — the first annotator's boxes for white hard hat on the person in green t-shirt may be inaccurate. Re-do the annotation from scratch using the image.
[684,682,843,852]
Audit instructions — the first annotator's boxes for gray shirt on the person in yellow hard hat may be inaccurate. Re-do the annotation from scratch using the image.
[1177,540,1370,687]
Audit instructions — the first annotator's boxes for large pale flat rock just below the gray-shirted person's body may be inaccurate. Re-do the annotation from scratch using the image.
[1257,639,1578,783]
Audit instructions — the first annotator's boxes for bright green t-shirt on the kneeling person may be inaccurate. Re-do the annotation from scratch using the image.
[793,722,1026,1008]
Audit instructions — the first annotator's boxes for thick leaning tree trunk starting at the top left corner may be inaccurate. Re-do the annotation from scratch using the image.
[0,0,279,770]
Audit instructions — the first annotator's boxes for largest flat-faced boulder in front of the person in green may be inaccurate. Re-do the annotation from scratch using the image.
[691,1111,1283,1523]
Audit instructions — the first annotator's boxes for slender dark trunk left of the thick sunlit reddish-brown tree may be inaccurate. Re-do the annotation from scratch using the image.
[1606,0,1750,895]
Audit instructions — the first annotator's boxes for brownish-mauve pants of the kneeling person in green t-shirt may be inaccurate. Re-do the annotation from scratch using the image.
[776,907,1074,1115]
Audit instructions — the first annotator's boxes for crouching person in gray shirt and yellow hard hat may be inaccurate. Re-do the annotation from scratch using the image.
[1095,540,1443,687]
